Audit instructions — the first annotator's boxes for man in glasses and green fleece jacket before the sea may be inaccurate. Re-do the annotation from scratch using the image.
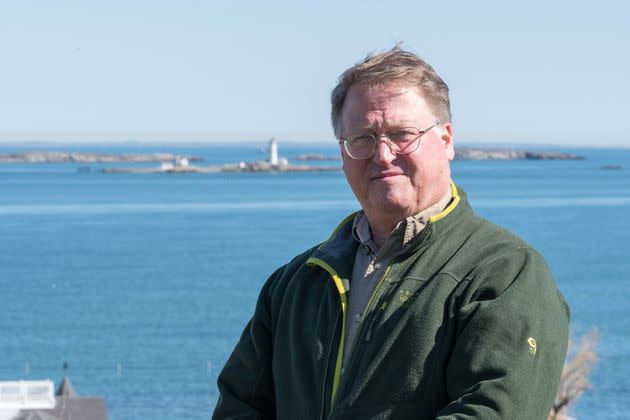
[214,48,568,420]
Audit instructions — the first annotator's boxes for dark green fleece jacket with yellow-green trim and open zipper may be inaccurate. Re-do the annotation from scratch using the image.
[213,187,569,420]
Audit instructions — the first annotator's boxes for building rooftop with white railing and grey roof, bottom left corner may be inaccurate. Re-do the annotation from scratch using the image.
[0,376,107,420]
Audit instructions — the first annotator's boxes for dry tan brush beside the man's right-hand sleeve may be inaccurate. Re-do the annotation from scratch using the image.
[547,331,599,420]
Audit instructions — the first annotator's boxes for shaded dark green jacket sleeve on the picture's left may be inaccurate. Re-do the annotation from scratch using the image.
[212,268,283,420]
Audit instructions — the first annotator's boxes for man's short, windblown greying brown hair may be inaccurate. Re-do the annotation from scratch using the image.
[330,45,451,138]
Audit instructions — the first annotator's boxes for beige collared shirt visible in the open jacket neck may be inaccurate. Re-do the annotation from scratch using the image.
[342,189,453,374]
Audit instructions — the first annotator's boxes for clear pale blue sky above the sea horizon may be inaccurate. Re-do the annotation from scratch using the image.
[0,0,630,146]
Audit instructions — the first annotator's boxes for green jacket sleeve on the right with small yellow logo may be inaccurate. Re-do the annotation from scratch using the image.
[437,248,569,420]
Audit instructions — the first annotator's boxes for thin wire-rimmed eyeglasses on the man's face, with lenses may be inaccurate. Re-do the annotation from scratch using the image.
[339,121,440,159]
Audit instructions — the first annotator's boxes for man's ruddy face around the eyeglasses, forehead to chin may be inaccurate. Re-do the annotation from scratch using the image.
[341,84,455,224]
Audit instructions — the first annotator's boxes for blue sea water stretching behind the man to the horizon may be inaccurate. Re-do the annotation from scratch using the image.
[0,146,630,420]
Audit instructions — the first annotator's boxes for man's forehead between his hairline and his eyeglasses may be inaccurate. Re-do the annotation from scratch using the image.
[342,84,433,128]
